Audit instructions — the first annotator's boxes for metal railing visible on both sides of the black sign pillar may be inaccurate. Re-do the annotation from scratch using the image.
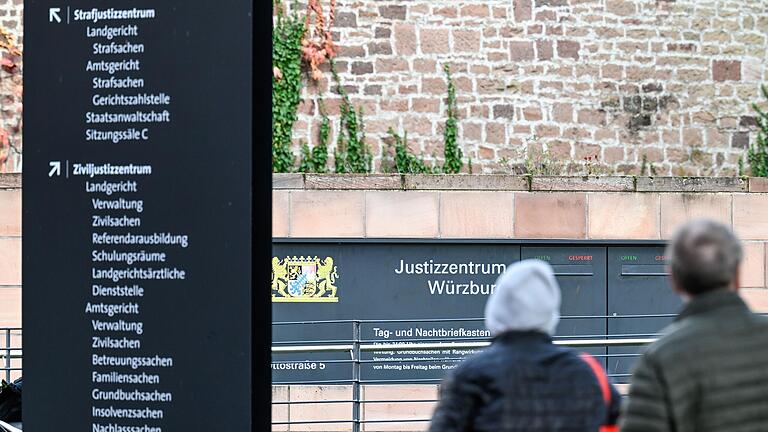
[0,324,673,432]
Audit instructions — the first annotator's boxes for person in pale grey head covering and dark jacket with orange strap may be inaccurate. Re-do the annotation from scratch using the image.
[429,260,621,432]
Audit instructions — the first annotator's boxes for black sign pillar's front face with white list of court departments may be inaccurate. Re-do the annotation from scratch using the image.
[23,0,252,432]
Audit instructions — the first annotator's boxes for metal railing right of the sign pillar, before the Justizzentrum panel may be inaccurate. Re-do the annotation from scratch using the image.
[271,314,675,432]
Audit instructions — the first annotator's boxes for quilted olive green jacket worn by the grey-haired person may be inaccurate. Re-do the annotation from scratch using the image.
[620,290,768,432]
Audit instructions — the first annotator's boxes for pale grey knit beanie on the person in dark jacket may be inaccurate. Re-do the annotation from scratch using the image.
[485,259,560,336]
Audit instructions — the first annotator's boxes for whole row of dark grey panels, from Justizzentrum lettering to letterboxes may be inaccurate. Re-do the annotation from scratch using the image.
[273,239,681,382]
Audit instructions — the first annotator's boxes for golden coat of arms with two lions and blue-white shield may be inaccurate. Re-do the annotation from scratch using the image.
[272,256,339,302]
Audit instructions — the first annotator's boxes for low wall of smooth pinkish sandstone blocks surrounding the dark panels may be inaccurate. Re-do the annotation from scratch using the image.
[272,174,768,431]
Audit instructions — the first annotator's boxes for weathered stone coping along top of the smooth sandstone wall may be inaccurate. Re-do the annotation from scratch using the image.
[272,173,768,193]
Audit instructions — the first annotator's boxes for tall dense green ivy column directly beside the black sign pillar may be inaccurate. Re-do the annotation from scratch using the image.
[272,0,306,172]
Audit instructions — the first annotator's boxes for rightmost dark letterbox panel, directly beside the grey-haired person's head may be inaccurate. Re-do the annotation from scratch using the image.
[608,246,681,383]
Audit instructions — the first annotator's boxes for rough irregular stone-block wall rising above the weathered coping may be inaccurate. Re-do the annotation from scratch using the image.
[295,0,768,176]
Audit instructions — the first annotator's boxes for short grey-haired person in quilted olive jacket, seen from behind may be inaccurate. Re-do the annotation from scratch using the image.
[620,220,768,432]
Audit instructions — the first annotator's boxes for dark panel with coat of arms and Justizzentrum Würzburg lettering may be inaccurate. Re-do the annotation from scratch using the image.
[273,242,520,382]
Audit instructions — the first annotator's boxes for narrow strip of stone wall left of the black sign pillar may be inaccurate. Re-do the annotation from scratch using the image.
[0,0,24,173]
